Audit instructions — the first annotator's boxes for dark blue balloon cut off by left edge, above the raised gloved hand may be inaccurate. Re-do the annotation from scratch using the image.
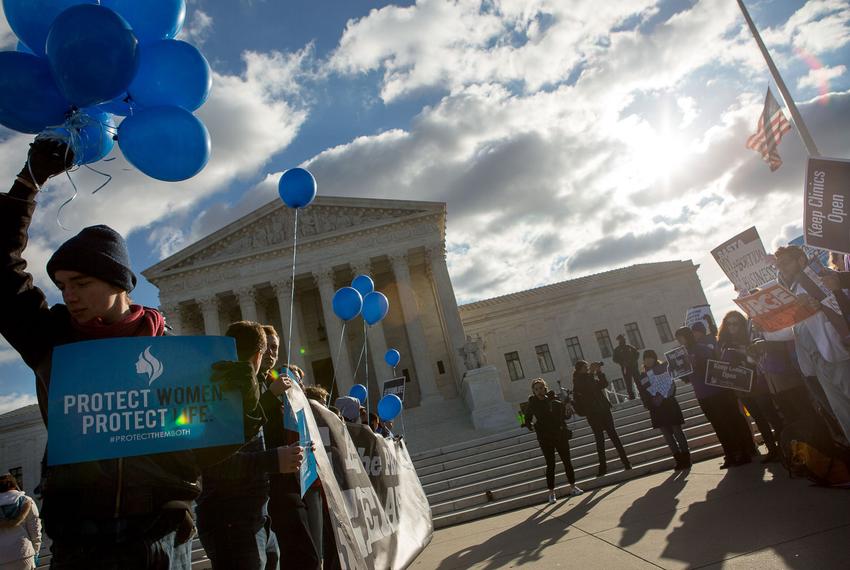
[0,51,71,133]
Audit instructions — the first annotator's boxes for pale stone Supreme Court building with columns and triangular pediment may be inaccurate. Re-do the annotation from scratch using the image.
[143,196,706,447]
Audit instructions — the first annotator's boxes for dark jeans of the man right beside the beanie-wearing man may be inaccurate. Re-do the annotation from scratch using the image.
[198,517,269,570]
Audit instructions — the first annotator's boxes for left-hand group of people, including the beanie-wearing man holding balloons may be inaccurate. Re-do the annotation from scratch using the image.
[0,140,400,570]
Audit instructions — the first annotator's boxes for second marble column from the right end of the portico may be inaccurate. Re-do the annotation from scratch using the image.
[388,255,443,404]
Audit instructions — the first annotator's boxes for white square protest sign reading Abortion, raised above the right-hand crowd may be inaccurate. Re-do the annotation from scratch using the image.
[711,227,776,293]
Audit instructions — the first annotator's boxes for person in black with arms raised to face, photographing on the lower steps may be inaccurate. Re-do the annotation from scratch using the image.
[573,360,632,477]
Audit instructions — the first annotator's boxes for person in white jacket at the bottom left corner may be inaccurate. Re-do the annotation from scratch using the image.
[0,473,41,570]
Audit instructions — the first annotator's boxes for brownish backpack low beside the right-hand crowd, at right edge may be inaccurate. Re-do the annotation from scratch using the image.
[780,414,850,488]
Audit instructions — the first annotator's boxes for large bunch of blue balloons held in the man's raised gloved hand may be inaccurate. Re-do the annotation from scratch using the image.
[0,0,212,181]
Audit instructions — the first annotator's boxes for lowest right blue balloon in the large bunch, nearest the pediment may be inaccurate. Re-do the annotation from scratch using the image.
[118,107,210,182]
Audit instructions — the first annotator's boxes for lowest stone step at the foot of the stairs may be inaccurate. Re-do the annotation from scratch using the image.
[433,443,723,529]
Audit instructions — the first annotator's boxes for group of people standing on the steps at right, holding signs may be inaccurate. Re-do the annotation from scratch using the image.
[524,242,850,503]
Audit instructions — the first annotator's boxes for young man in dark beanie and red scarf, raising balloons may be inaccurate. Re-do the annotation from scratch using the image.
[0,136,262,570]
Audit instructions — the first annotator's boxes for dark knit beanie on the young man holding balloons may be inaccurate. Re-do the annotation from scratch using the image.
[47,225,136,291]
